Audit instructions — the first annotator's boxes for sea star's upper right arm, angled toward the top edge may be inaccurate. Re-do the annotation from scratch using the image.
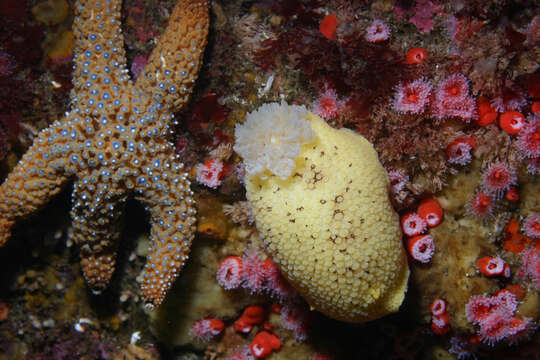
[135,0,209,110]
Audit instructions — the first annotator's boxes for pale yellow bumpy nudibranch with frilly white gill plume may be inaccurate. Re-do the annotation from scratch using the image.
[234,102,409,322]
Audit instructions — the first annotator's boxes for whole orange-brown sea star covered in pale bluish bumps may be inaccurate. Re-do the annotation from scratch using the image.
[0,0,209,307]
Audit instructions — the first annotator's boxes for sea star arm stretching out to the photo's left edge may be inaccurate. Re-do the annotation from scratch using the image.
[0,119,77,247]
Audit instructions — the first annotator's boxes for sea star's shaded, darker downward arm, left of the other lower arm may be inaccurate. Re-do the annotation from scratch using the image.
[71,176,127,293]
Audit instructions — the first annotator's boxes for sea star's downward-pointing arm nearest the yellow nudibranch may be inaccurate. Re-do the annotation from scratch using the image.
[135,152,196,308]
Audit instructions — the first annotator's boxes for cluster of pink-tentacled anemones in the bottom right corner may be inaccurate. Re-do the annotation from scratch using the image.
[465,289,532,345]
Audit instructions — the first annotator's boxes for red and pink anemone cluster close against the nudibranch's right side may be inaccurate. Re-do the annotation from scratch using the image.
[401,197,443,263]
